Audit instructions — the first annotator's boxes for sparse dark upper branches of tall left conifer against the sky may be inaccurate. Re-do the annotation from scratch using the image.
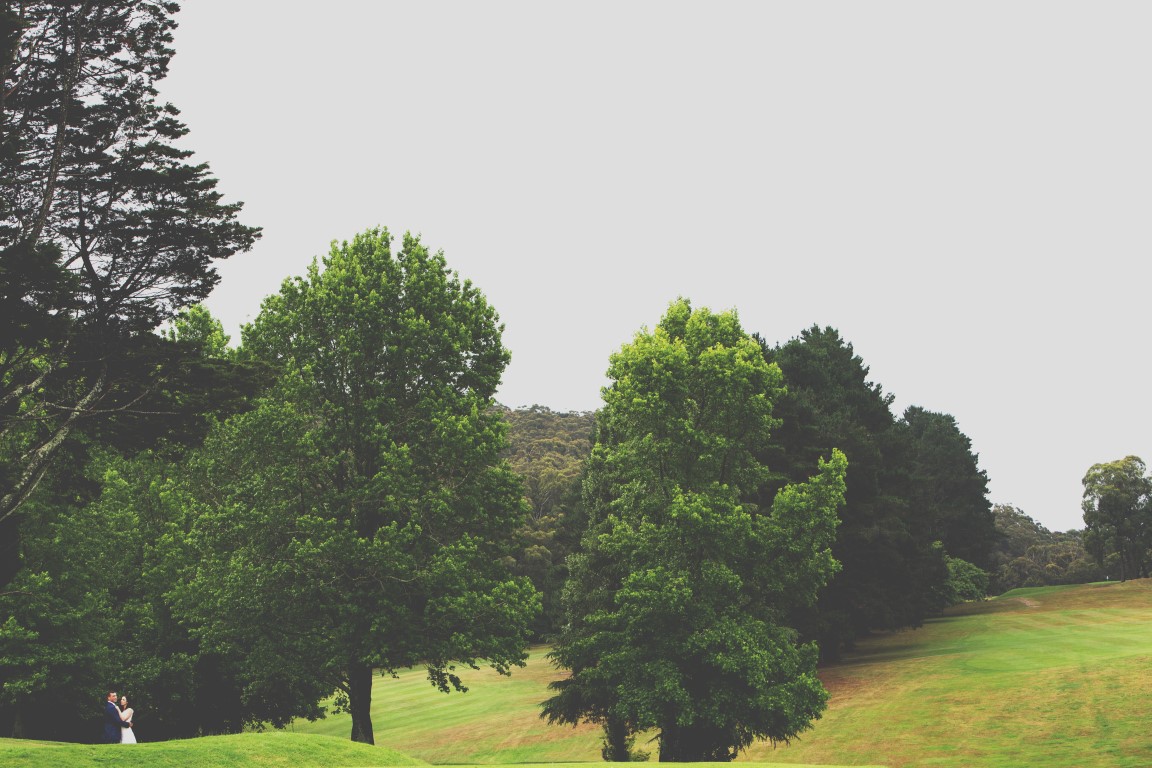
[0,0,258,329]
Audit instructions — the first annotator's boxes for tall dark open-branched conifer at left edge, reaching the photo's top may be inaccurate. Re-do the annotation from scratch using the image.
[0,0,258,584]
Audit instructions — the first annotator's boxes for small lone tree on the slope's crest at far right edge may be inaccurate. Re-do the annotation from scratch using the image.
[1082,456,1152,580]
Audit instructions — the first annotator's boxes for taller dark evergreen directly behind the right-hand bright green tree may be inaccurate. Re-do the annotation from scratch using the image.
[764,326,948,657]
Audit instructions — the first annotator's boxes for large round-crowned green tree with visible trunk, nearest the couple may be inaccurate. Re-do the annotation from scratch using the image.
[173,229,539,743]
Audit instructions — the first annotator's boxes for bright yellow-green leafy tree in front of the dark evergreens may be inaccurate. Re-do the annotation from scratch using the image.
[544,299,846,761]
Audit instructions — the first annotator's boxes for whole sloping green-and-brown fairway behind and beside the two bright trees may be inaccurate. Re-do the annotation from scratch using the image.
[296,580,1152,768]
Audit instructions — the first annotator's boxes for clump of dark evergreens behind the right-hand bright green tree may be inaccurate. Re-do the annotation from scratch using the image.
[761,326,993,659]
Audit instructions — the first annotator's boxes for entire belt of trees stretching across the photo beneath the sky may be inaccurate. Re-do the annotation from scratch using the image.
[0,0,1133,760]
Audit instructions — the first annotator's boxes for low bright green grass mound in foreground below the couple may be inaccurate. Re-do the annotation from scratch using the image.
[0,732,424,768]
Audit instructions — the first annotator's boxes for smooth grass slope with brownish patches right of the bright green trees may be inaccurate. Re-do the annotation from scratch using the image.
[748,579,1152,768]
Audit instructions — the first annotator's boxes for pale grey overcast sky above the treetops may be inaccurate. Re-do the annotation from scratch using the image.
[161,0,1152,530]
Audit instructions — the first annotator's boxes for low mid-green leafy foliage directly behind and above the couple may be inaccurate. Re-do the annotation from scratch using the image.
[0,451,256,740]
